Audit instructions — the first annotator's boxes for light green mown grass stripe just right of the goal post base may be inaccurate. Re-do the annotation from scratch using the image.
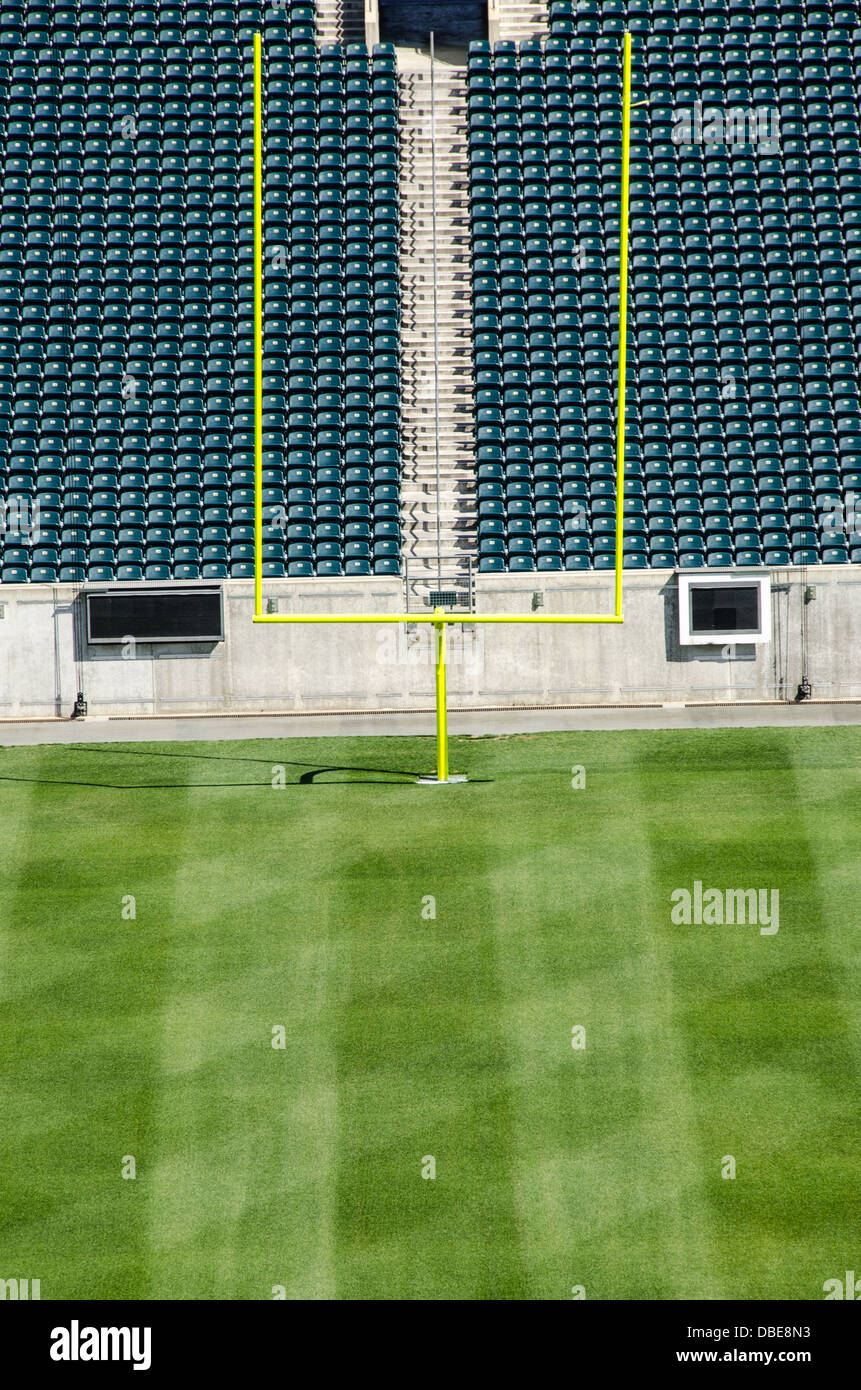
[492,735,715,1298]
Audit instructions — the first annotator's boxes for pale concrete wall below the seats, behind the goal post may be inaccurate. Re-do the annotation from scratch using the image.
[0,566,861,717]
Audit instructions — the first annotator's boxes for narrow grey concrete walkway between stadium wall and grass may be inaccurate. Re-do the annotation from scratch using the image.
[0,701,861,748]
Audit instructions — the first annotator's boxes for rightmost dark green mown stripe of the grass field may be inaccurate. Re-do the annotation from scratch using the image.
[643,730,858,1298]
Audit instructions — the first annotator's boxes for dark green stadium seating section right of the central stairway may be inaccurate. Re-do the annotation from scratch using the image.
[469,16,861,571]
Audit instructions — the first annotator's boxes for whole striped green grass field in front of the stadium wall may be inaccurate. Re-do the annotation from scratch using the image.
[0,728,861,1300]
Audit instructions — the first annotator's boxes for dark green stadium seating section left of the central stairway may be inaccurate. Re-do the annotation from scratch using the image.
[0,6,401,582]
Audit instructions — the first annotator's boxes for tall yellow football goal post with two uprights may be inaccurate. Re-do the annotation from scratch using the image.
[252,31,631,784]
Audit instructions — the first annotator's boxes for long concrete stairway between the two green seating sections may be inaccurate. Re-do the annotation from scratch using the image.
[398,49,477,597]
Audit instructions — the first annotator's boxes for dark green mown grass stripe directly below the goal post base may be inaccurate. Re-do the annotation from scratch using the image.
[332,772,524,1300]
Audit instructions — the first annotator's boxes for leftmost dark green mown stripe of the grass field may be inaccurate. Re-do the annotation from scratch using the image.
[0,746,191,1298]
